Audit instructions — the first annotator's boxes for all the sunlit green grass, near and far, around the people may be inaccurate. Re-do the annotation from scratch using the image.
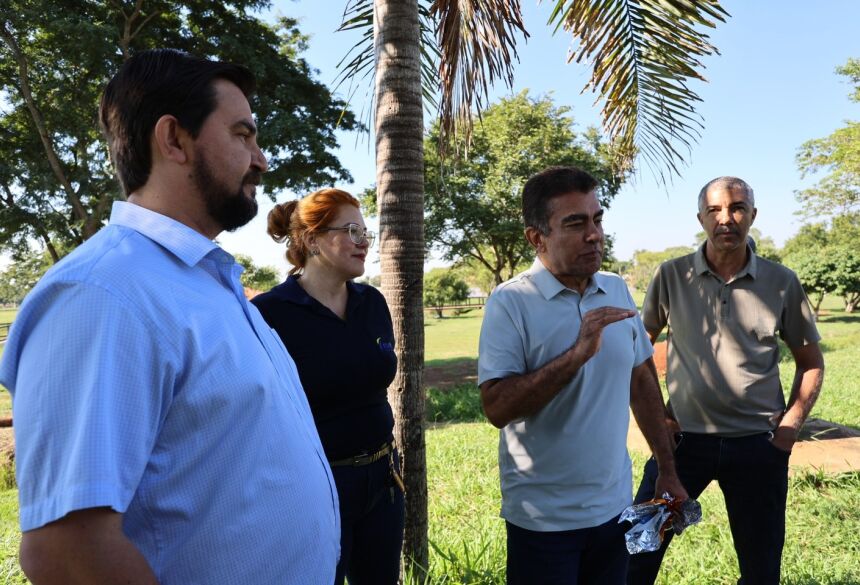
[0,298,860,585]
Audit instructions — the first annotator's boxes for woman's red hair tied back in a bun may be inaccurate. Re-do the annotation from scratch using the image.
[266,189,359,274]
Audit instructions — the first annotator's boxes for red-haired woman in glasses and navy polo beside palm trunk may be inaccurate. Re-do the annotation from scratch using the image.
[252,189,404,585]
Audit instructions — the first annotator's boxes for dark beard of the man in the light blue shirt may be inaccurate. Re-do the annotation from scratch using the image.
[193,156,262,232]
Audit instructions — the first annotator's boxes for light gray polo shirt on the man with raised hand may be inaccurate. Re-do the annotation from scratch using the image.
[478,259,653,532]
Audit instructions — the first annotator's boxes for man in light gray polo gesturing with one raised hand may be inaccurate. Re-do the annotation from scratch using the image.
[478,167,686,585]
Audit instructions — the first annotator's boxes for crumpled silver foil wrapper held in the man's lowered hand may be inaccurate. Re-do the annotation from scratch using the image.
[618,494,702,555]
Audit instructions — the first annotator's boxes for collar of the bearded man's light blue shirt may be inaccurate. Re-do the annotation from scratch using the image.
[110,201,220,266]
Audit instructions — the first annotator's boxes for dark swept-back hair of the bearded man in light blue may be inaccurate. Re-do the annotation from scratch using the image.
[99,49,255,195]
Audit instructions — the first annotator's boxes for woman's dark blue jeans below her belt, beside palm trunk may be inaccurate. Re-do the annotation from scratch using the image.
[332,452,404,585]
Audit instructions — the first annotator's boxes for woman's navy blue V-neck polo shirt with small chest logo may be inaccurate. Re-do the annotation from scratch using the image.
[251,275,397,460]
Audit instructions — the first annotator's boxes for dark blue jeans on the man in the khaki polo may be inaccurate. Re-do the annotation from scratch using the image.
[627,433,789,585]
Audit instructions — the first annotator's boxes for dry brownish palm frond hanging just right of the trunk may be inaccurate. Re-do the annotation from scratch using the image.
[430,0,528,144]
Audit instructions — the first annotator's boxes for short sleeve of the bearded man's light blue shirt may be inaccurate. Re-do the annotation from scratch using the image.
[3,282,179,531]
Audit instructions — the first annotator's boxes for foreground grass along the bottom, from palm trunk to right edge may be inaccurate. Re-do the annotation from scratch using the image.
[427,423,860,585]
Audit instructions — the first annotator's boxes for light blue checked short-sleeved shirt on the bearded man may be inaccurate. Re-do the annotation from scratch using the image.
[0,202,340,585]
